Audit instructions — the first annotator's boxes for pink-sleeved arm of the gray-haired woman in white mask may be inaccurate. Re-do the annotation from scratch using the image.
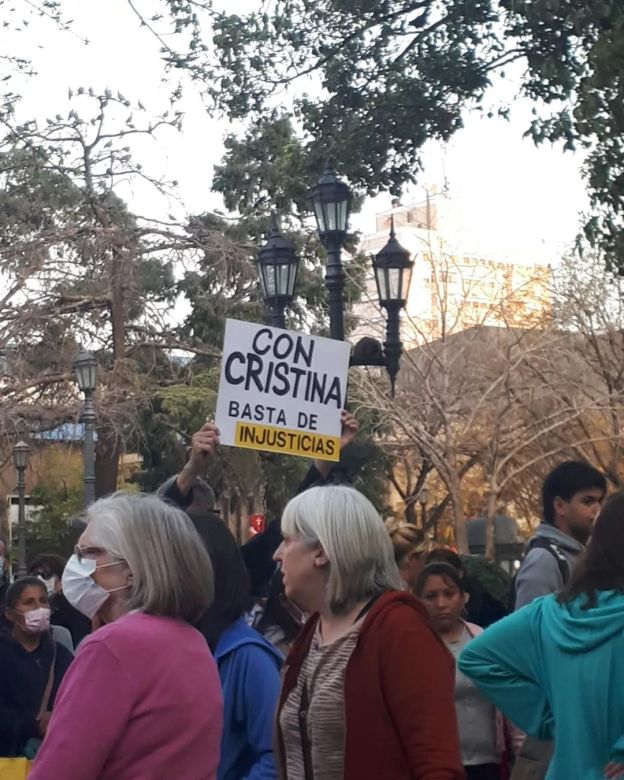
[28,641,134,780]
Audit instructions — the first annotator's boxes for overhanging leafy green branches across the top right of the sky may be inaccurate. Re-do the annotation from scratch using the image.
[154,0,624,271]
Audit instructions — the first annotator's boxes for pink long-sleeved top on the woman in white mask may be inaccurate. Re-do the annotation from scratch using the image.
[29,613,223,780]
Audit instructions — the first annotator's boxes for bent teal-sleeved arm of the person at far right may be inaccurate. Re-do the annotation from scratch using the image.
[458,602,553,740]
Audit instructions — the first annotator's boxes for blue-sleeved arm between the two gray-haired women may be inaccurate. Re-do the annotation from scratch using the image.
[241,645,281,780]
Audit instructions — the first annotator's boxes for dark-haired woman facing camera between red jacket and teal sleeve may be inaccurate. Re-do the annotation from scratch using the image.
[415,563,505,780]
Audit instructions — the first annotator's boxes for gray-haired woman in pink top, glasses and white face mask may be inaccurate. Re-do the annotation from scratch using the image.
[29,494,222,780]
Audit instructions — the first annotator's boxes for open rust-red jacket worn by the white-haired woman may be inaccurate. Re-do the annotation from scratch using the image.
[276,591,464,780]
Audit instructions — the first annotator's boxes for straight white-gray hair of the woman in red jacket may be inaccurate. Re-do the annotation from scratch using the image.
[282,485,402,614]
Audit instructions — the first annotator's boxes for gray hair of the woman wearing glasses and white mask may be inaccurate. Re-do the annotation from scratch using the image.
[86,493,214,623]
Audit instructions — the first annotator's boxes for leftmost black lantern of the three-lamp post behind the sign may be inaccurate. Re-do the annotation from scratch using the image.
[256,220,299,328]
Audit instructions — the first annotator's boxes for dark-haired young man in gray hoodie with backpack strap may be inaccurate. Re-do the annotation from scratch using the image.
[514,460,607,609]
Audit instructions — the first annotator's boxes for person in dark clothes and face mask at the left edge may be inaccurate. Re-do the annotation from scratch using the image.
[0,577,72,758]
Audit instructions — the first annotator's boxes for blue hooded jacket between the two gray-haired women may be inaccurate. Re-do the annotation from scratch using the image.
[215,618,283,780]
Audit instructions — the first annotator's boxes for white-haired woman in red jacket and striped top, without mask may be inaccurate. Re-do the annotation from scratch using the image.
[275,486,463,780]
